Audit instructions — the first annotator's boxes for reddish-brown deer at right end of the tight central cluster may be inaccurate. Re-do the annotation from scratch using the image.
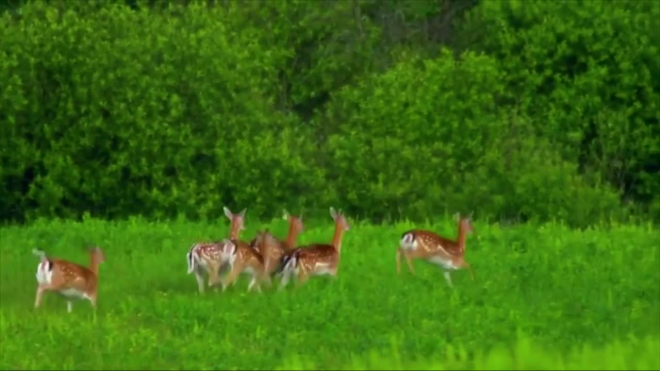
[280,207,350,290]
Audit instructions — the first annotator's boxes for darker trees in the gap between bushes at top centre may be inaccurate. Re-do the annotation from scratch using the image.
[223,0,379,117]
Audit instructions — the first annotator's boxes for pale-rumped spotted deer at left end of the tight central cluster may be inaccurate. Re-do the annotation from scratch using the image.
[186,206,247,294]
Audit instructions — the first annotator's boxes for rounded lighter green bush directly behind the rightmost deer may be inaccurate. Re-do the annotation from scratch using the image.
[324,50,618,225]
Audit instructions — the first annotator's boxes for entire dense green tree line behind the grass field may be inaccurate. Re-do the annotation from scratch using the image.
[0,0,660,225]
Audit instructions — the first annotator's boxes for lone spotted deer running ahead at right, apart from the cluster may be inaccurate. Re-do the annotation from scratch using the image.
[396,214,474,287]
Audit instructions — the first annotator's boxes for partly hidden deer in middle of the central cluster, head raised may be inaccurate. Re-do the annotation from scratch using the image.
[251,210,305,284]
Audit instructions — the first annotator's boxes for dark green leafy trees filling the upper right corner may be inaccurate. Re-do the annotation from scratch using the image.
[459,0,660,215]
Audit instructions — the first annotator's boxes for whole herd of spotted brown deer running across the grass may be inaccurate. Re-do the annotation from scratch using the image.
[33,207,474,312]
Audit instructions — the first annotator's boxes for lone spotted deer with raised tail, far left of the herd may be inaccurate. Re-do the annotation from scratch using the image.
[32,247,105,313]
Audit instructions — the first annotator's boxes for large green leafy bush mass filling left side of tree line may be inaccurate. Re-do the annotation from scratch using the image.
[0,3,322,218]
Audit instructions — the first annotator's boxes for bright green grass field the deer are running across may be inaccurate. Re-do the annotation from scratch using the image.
[0,216,660,369]
